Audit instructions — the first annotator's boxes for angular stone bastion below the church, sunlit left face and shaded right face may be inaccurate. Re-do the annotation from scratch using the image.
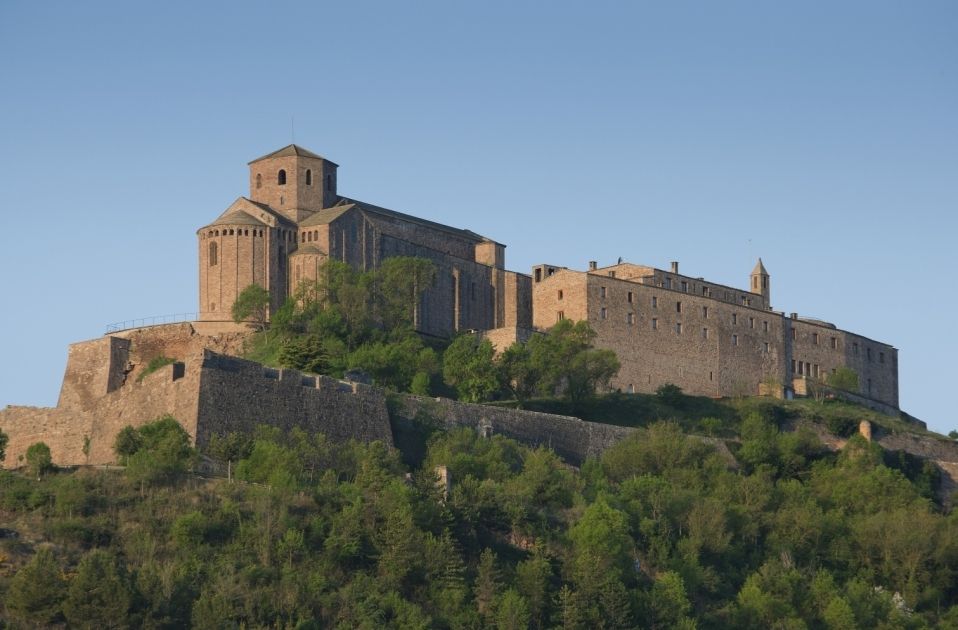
[0,324,392,468]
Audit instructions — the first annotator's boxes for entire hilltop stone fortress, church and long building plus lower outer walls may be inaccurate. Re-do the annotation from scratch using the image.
[0,145,899,467]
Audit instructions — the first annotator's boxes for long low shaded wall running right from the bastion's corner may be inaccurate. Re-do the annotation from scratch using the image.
[393,396,636,464]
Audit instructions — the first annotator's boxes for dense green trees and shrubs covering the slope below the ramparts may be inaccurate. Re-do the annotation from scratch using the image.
[0,414,958,628]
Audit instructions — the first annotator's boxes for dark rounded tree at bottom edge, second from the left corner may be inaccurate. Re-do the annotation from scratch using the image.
[63,549,132,628]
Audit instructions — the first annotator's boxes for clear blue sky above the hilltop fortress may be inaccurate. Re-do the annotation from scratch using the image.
[0,0,958,431]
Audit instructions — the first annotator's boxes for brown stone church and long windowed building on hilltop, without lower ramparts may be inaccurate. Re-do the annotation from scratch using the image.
[197,145,898,412]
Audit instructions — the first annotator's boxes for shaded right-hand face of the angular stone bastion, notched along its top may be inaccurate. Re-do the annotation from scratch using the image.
[193,350,393,447]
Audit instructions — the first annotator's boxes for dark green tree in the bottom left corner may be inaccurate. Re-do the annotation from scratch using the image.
[5,547,66,627]
